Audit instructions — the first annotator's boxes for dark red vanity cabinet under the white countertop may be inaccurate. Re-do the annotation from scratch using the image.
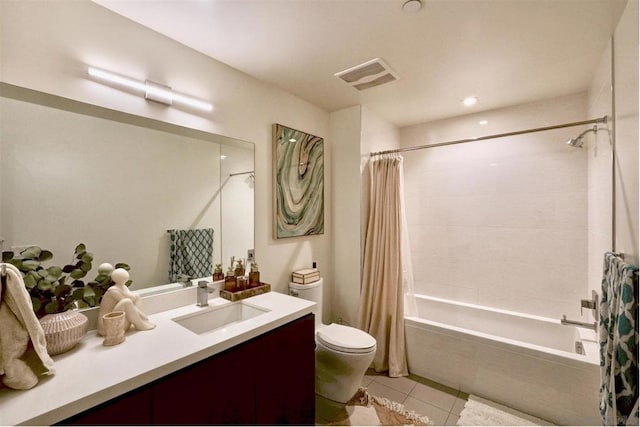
[60,314,315,425]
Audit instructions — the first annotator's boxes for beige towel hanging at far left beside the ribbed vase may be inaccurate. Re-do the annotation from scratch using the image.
[0,264,53,390]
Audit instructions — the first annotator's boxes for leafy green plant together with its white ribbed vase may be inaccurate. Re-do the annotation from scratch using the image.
[2,243,130,355]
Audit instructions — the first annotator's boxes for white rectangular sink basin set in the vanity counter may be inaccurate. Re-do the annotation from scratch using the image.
[171,301,269,335]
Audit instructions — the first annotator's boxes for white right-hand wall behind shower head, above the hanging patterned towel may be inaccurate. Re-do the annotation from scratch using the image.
[588,1,639,308]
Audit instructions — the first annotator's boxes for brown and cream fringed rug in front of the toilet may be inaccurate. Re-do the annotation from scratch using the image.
[328,388,431,426]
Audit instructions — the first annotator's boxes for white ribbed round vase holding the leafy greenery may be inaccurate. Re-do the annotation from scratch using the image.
[40,310,89,356]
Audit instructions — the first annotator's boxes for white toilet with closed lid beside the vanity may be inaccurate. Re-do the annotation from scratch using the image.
[289,279,376,403]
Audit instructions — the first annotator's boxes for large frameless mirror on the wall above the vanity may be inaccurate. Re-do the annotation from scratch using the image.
[0,83,254,290]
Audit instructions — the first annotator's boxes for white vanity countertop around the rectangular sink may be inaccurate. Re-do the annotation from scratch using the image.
[0,292,315,425]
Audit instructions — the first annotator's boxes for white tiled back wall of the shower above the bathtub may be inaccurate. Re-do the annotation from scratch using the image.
[401,94,587,318]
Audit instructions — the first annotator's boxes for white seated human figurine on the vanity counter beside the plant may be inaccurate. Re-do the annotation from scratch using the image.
[98,268,156,336]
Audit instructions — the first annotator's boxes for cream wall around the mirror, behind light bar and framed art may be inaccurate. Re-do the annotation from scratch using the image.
[0,0,333,291]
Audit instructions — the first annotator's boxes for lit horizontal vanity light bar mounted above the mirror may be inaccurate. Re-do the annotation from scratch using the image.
[87,67,213,111]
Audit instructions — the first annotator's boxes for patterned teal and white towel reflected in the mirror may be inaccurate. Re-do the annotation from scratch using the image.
[167,228,213,282]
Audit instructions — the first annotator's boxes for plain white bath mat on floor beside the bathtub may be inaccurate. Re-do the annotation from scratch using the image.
[457,395,553,426]
